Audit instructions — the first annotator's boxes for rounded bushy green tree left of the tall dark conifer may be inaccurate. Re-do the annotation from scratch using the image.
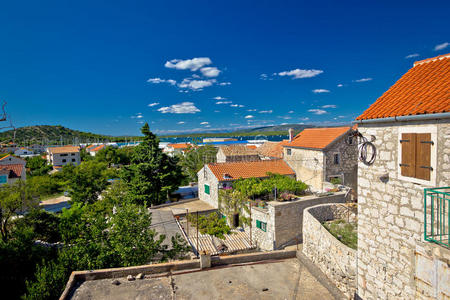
[68,161,108,203]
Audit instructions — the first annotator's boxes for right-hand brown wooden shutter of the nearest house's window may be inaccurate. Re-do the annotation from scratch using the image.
[415,133,432,180]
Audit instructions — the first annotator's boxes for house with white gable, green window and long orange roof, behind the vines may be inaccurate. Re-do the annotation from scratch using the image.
[197,159,295,208]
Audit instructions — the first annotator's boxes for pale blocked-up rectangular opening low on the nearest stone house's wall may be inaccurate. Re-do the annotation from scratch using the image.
[414,243,450,299]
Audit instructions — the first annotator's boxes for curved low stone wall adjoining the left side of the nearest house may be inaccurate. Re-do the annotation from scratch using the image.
[303,203,357,298]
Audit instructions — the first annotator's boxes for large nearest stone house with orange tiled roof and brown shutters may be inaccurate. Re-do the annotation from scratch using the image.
[355,54,450,299]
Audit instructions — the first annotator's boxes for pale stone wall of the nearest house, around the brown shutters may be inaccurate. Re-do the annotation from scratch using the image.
[358,120,450,299]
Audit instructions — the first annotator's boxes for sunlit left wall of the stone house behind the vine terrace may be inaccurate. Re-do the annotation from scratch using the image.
[283,147,325,191]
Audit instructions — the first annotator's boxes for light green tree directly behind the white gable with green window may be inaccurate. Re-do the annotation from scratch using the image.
[180,145,217,182]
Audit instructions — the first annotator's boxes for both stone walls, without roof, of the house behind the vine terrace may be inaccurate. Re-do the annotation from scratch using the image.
[283,134,358,191]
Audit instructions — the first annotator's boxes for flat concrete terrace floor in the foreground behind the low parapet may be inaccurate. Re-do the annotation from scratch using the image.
[72,258,335,300]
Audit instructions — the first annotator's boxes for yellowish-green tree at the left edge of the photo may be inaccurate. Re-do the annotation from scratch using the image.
[0,180,38,242]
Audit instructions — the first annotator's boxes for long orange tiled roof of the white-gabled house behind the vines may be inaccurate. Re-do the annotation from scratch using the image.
[208,159,295,181]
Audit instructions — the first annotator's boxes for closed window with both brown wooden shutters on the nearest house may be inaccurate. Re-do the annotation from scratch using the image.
[400,133,434,181]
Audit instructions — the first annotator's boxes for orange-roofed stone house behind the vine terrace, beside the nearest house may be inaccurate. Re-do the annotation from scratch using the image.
[283,127,358,191]
